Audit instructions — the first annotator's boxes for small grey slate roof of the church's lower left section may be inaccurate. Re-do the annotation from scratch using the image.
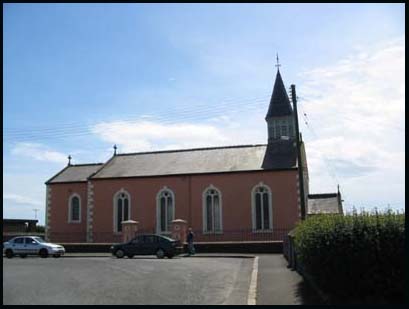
[46,163,103,184]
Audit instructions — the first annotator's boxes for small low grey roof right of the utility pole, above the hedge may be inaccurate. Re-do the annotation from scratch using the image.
[307,193,342,215]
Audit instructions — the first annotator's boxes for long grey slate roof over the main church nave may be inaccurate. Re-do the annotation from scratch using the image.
[91,145,296,179]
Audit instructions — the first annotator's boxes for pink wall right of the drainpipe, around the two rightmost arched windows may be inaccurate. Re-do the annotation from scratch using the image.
[191,171,298,230]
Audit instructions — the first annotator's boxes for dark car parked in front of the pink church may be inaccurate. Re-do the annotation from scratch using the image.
[110,234,180,259]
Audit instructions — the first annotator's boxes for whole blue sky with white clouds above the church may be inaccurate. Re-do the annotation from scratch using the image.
[3,4,405,223]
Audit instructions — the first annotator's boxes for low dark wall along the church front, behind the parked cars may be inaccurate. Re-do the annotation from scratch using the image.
[61,241,283,253]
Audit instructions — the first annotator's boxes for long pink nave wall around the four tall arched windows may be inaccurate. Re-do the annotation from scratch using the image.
[92,170,299,242]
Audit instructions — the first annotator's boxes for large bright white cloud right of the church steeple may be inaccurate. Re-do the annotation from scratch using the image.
[298,38,405,209]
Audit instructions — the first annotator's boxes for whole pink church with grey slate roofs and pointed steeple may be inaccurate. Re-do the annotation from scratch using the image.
[46,70,322,243]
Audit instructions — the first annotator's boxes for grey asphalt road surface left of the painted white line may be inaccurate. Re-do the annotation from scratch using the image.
[3,257,253,305]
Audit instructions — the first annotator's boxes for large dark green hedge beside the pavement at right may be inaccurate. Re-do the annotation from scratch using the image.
[294,210,405,303]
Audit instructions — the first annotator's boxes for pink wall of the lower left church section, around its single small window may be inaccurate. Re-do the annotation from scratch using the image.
[49,183,87,242]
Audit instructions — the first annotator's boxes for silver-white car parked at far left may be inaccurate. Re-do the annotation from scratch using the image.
[3,236,65,259]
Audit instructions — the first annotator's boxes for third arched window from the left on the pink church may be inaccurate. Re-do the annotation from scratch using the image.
[156,187,175,233]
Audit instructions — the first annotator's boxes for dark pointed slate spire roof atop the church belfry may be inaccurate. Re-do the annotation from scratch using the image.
[266,70,292,119]
